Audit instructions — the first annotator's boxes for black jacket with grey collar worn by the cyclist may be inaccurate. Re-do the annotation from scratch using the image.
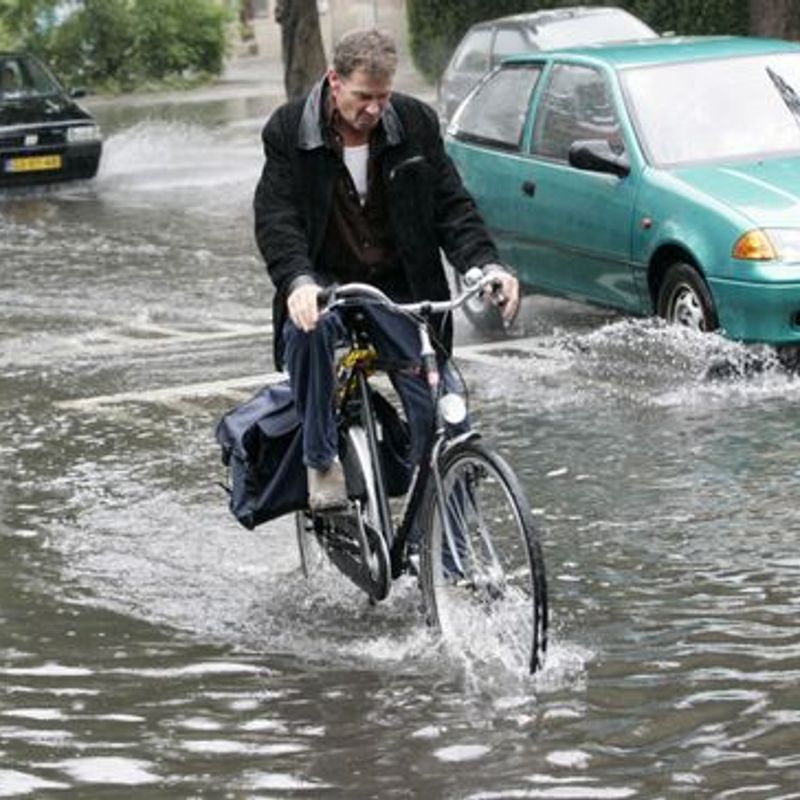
[254,80,499,369]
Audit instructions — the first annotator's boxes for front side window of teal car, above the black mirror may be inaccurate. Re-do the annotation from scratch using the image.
[531,64,625,161]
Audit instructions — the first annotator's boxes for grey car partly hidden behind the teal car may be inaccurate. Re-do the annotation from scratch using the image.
[439,6,658,121]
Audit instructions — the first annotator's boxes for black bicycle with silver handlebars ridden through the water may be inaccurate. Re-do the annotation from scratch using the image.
[296,270,548,672]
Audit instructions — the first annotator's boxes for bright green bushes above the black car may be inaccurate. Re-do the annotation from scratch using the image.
[0,0,228,90]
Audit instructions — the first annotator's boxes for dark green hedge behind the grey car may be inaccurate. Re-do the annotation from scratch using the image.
[406,0,752,80]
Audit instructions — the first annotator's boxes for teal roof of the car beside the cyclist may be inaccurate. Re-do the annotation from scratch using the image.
[506,36,800,69]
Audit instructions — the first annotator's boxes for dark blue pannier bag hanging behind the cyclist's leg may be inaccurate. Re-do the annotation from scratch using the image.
[216,382,308,530]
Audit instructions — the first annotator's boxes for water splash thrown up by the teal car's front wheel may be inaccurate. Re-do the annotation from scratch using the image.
[468,318,800,410]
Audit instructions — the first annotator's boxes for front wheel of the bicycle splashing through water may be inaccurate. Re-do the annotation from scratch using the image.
[420,440,547,672]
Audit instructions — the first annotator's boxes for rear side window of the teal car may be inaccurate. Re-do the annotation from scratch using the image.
[451,64,542,150]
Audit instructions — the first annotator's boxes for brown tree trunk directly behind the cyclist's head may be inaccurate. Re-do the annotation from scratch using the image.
[275,0,327,100]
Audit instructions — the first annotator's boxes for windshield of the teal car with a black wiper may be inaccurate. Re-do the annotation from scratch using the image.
[620,53,800,166]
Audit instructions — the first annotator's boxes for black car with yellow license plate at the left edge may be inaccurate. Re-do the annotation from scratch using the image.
[0,53,102,186]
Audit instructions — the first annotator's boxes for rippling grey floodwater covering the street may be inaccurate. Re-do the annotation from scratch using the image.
[0,65,800,800]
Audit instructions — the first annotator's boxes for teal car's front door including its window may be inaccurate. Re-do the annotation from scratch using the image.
[512,61,643,311]
